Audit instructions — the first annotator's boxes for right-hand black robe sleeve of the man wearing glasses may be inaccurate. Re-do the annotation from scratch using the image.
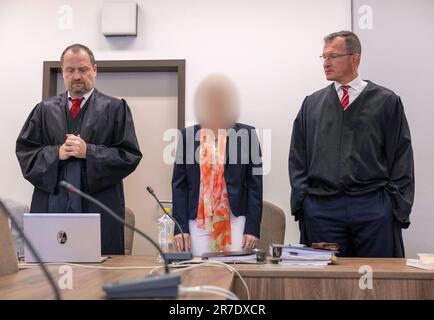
[384,95,414,228]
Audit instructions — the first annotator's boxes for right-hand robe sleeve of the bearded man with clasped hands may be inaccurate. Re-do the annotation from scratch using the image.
[86,100,142,193]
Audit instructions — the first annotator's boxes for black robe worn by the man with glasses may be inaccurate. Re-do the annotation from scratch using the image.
[289,81,414,228]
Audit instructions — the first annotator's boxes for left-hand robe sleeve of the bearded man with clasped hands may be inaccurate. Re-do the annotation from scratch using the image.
[15,103,60,194]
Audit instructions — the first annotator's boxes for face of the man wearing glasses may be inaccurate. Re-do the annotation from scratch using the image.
[323,37,360,84]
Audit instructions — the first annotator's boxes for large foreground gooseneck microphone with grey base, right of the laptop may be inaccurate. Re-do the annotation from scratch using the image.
[59,181,181,299]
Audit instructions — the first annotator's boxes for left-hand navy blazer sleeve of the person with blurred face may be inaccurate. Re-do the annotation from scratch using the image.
[172,129,190,234]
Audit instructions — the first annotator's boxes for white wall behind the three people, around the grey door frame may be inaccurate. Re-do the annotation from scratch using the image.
[0,0,351,242]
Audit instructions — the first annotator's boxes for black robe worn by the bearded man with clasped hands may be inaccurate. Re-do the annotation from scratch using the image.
[16,89,142,254]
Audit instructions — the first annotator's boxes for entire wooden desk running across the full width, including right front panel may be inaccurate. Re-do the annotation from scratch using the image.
[0,256,434,300]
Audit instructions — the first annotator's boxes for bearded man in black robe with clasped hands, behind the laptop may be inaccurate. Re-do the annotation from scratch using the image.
[16,44,142,255]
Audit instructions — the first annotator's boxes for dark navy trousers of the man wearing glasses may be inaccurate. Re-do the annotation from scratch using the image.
[299,190,405,257]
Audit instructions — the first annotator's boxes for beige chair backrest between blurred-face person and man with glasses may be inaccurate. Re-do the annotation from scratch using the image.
[257,201,286,256]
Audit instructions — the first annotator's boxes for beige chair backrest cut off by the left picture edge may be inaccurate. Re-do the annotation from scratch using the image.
[0,201,18,276]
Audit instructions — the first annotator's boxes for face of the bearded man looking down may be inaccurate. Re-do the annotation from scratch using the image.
[62,50,96,97]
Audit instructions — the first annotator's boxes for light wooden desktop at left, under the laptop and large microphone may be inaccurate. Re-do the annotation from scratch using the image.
[0,256,233,300]
